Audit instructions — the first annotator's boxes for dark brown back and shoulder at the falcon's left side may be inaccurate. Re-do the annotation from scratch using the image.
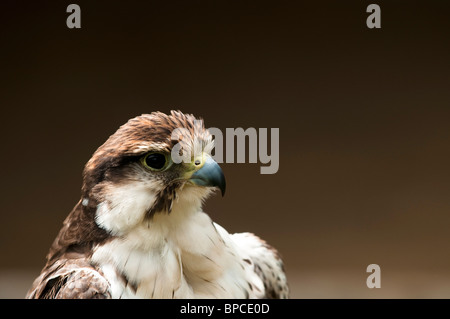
[26,203,111,299]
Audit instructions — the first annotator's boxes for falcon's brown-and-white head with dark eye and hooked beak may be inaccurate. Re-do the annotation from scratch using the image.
[82,111,225,235]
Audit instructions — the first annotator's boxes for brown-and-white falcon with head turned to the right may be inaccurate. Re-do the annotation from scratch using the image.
[26,111,289,299]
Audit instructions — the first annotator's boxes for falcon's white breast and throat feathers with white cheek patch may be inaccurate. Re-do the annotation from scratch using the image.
[92,182,264,298]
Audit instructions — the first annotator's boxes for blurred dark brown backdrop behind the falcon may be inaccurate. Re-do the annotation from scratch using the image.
[0,0,450,298]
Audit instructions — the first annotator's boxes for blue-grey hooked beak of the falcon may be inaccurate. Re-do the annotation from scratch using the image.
[189,156,226,196]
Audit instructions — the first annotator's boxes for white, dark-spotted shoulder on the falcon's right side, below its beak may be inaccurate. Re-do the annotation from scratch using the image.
[232,233,289,299]
